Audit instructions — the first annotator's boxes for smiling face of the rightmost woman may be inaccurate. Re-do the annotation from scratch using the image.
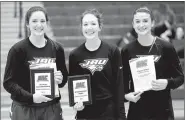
[133,12,154,35]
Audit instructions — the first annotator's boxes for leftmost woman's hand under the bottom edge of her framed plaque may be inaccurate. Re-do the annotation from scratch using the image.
[33,93,52,103]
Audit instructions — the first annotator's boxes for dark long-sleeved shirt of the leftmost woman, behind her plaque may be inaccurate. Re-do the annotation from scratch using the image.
[3,38,68,106]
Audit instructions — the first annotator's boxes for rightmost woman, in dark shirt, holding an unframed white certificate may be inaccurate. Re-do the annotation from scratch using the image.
[121,7,184,120]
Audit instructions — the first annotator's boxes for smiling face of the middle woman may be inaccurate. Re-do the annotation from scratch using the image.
[82,14,101,39]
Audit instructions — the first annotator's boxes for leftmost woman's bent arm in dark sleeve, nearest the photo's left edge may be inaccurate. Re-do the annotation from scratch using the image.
[3,48,33,103]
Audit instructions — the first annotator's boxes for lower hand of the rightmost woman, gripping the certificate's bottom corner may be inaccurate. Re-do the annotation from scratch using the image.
[125,91,143,103]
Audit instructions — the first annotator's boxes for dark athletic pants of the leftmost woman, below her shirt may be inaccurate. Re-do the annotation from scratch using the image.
[11,102,63,120]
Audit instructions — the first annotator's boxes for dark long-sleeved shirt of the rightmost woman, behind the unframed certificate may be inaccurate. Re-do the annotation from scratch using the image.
[121,37,184,120]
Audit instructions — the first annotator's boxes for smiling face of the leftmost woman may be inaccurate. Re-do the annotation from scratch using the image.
[27,11,47,36]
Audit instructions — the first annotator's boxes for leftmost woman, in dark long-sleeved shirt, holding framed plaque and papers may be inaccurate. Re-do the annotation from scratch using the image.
[3,6,68,120]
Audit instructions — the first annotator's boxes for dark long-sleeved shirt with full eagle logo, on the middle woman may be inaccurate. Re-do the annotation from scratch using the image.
[69,41,125,119]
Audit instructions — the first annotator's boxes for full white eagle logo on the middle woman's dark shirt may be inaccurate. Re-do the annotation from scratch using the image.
[79,58,108,75]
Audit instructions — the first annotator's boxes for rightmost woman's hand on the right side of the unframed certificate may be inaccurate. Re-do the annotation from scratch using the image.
[152,79,168,91]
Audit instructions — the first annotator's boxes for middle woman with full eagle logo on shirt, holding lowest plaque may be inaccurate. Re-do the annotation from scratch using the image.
[69,9,125,120]
